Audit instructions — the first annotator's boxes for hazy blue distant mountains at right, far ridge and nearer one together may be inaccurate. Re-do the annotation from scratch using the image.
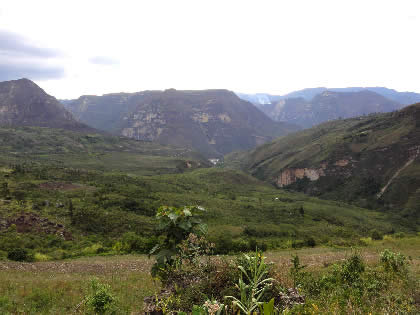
[237,87,420,128]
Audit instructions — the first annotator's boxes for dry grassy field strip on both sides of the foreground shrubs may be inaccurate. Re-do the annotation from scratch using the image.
[0,237,420,314]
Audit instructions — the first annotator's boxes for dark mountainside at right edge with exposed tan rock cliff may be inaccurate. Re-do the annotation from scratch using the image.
[225,103,420,223]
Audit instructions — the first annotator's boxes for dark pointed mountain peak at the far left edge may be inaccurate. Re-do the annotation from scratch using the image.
[0,79,93,131]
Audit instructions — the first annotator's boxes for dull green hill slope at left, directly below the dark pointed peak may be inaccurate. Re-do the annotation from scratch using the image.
[0,127,210,175]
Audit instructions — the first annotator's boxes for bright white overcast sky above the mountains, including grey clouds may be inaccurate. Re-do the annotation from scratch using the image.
[0,0,420,98]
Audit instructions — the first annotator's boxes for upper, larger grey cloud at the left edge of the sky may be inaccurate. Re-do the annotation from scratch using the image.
[0,30,62,58]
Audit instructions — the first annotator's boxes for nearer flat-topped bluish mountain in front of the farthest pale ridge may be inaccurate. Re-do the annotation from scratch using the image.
[264,90,402,128]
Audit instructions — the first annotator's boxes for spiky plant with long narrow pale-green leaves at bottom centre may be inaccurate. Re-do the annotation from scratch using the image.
[225,251,274,314]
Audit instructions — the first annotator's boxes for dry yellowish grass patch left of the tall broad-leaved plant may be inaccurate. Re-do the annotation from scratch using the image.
[0,256,159,314]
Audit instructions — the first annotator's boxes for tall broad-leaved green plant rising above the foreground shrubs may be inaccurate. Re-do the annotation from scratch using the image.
[150,206,207,276]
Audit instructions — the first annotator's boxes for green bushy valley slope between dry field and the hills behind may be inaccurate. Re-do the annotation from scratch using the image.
[0,164,411,260]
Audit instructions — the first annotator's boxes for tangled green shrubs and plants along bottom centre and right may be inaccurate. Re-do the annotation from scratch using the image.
[146,212,419,315]
